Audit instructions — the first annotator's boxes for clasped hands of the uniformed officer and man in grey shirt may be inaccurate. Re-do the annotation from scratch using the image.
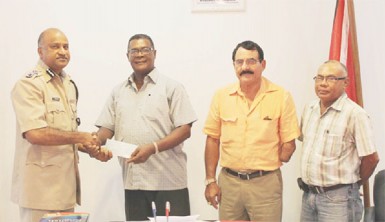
[77,132,112,162]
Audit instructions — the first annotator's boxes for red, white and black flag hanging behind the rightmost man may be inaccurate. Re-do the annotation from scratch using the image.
[329,0,363,106]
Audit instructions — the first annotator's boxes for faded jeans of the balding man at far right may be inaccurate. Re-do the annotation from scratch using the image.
[301,184,363,222]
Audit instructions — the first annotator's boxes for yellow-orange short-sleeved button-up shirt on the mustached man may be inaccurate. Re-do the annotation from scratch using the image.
[203,77,300,170]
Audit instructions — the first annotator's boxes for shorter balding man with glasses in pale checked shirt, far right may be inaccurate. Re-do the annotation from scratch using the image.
[299,60,379,221]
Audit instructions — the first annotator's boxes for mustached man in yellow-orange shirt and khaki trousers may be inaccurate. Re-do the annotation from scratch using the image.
[203,41,300,221]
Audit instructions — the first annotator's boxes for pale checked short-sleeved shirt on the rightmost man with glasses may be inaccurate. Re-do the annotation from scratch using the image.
[300,94,376,186]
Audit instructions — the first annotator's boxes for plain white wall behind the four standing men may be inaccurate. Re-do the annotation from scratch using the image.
[0,0,385,222]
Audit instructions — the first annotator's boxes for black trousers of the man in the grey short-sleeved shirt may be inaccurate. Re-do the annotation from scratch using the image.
[125,188,190,221]
